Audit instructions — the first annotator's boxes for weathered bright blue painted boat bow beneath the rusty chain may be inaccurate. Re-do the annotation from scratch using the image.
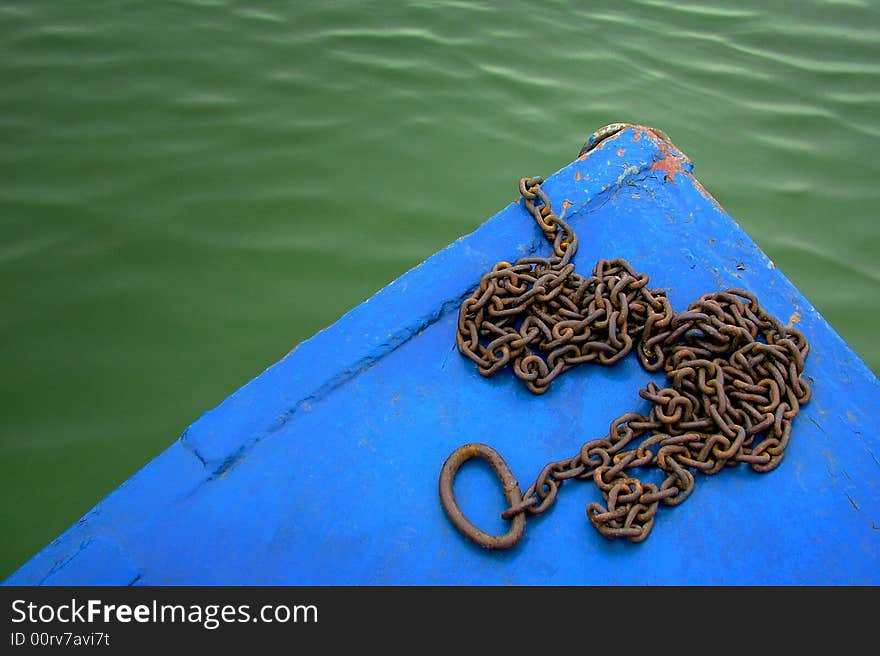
[6,127,880,585]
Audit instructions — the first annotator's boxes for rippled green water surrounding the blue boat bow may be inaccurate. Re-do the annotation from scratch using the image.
[0,0,880,578]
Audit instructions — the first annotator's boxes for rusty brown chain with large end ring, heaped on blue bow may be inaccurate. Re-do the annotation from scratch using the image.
[440,156,811,549]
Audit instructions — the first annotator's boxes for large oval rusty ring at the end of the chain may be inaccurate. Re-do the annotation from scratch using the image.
[440,443,526,549]
